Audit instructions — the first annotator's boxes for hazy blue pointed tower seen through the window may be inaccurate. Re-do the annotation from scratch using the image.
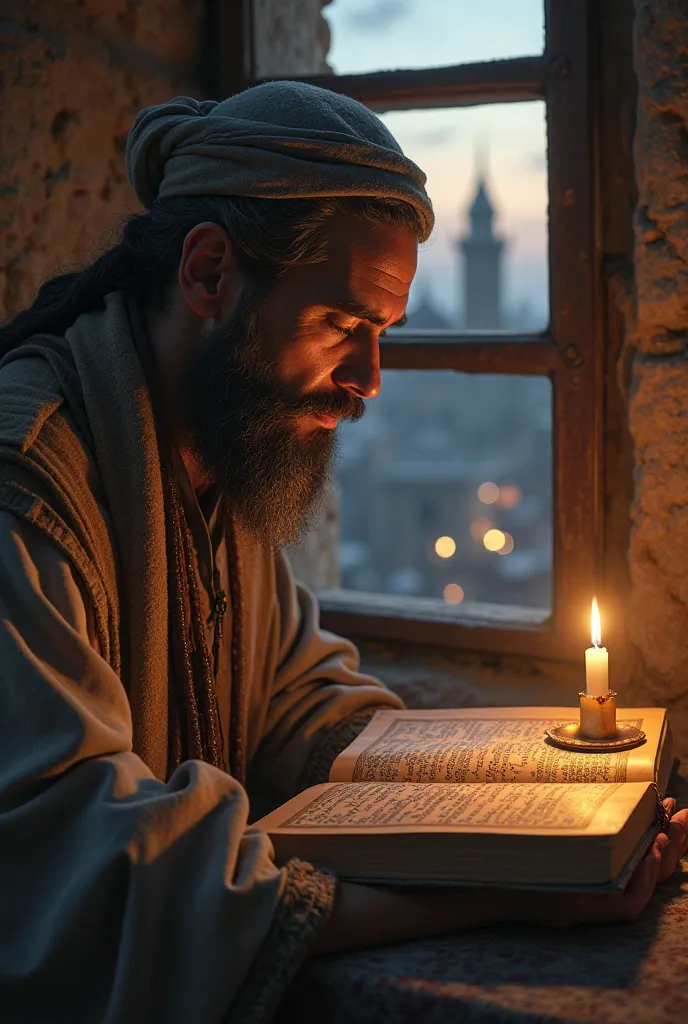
[460,153,504,331]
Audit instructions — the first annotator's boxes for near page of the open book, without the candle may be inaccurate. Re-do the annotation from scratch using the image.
[272,782,622,834]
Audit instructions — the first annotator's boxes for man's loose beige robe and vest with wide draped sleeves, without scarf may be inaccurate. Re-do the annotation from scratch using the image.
[0,293,400,1024]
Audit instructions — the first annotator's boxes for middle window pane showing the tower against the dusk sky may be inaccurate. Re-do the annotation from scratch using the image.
[382,101,549,332]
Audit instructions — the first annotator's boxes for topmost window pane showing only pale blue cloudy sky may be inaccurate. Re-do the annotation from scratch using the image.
[323,0,545,75]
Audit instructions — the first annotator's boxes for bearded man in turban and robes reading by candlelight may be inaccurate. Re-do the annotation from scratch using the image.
[0,83,685,1024]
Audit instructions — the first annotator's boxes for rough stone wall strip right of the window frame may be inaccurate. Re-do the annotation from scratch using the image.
[630,0,688,757]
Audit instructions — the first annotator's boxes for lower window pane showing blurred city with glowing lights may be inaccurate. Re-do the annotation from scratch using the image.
[338,371,552,611]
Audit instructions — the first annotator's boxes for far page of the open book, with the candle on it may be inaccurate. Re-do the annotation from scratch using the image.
[330,708,663,783]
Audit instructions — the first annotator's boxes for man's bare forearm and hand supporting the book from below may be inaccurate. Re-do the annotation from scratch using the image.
[313,800,688,953]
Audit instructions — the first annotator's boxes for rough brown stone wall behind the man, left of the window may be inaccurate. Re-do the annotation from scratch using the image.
[0,0,206,319]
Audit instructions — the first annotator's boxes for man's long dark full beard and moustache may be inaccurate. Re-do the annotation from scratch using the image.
[186,287,366,547]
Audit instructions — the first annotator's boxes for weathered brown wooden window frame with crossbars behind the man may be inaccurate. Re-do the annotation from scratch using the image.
[215,0,604,658]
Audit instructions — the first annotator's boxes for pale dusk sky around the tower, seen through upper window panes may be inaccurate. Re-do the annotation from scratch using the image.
[324,0,547,326]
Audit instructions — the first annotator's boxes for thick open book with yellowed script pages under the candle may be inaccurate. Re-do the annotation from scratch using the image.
[257,708,672,890]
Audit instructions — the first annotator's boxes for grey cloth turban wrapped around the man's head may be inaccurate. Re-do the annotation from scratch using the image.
[127,82,434,241]
